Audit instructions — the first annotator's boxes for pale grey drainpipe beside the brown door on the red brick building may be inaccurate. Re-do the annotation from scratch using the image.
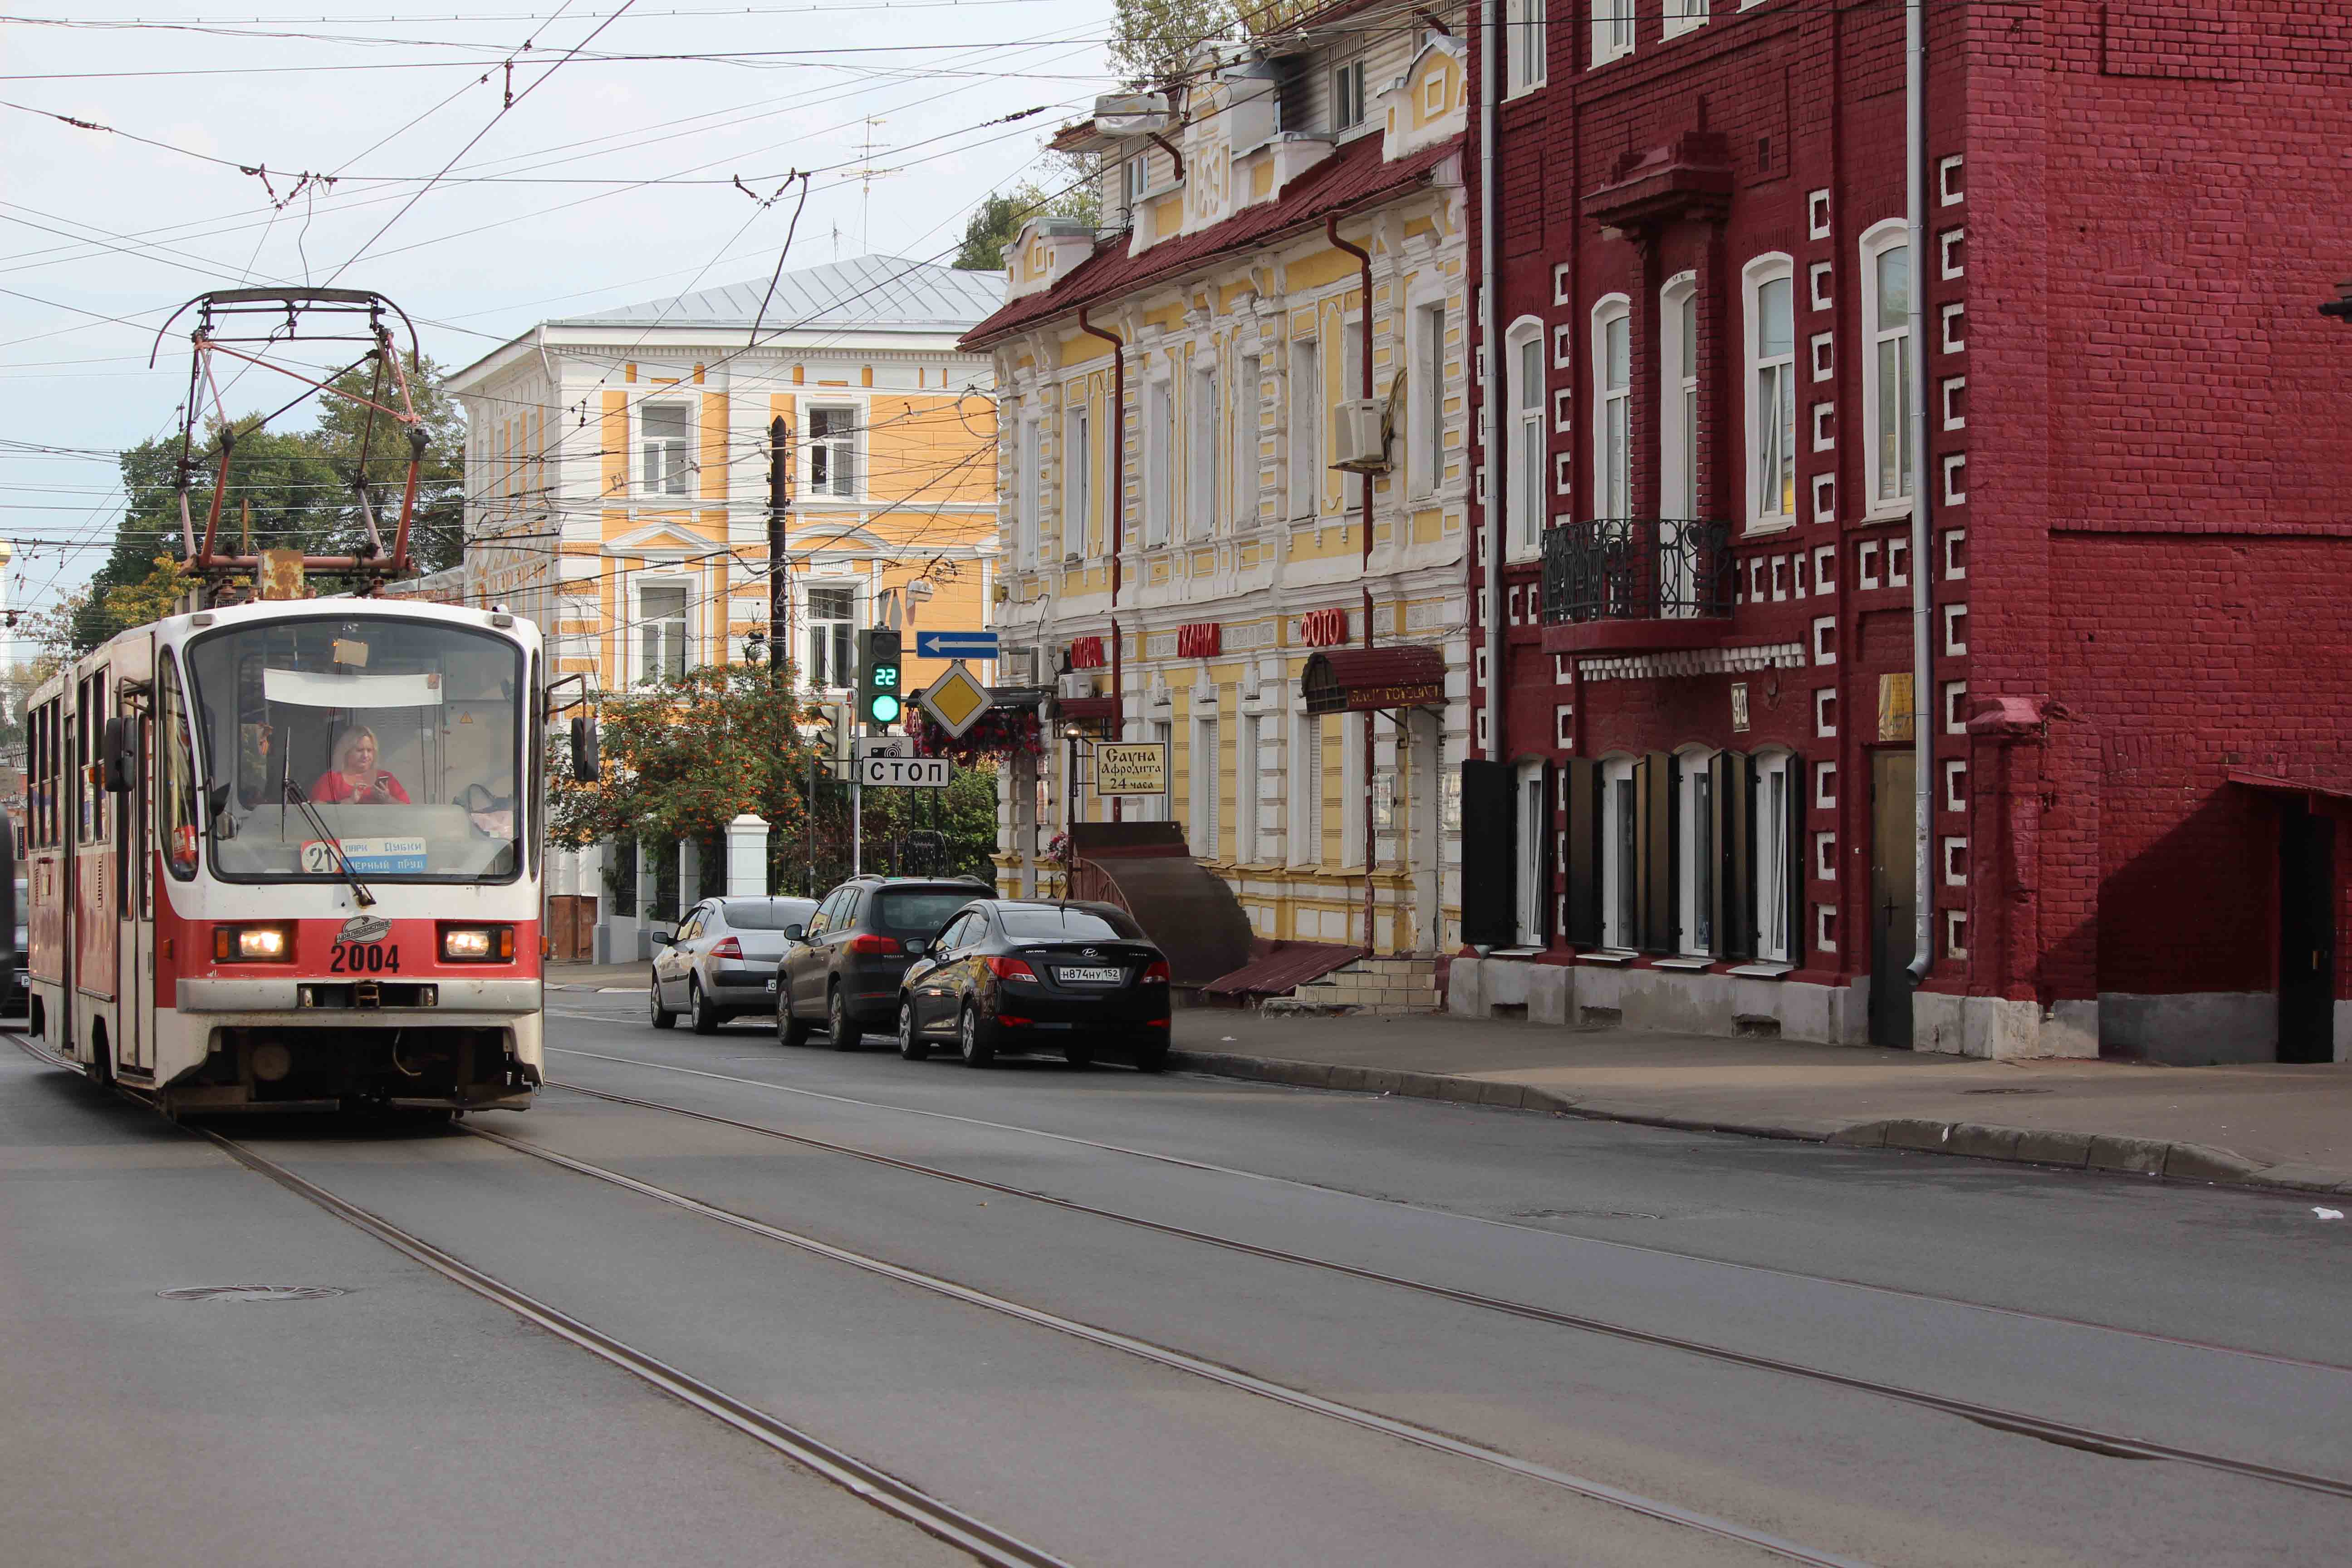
[1903,0,1936,985]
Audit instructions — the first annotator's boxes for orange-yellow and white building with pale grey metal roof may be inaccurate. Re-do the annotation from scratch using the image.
[449,256,1000,959]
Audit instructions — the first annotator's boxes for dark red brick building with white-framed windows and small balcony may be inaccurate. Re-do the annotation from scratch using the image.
[1454,0,2352,1060]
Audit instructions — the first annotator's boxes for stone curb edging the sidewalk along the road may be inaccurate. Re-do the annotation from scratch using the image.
[1166,1051,2352,1196]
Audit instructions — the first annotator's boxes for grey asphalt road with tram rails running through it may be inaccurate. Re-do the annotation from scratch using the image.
[0,995,2352,1566]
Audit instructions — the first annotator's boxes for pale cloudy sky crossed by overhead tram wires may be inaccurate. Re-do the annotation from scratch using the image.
[0,0,1115,609]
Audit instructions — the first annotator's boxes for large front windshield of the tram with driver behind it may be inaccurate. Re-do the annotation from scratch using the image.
[188,616,524,882]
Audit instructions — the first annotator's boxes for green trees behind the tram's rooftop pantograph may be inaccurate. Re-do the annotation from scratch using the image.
[63,360,466,653]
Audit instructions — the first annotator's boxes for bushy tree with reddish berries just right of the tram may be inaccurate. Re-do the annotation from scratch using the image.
[550,665,814,846]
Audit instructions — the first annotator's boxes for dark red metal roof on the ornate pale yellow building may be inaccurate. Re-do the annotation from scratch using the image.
[960,137,1454,350]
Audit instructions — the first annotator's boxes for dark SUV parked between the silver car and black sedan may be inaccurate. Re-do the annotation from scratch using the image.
[776,877,988,1051]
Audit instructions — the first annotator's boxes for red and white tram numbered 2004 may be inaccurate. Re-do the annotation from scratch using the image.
[24,597,546,1114]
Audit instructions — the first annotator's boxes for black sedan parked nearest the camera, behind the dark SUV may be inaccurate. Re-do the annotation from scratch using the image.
[898,898,1169,1072]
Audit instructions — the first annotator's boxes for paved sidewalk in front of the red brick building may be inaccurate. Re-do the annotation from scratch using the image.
[1169,1009,2352,1196]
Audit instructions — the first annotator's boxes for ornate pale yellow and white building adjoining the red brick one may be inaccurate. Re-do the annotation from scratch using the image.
[964,15,1472,955]
